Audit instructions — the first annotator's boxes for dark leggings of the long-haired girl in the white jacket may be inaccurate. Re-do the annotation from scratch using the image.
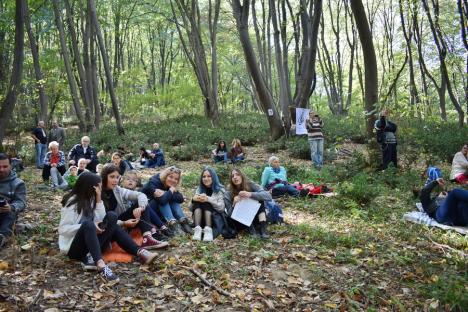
[68,212,139,262]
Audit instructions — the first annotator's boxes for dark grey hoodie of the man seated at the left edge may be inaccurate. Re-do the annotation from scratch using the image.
[0,170,26,212]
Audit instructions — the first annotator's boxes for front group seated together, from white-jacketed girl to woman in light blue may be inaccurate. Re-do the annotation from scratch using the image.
[55,156,304,283]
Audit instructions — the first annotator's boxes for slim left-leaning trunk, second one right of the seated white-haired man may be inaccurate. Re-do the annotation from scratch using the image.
[88,0,125,135]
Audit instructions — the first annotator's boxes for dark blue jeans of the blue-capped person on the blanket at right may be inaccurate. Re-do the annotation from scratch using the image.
[435,189,468,226]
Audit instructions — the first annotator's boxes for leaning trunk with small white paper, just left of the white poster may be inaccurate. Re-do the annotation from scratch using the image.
[232,0,284,140]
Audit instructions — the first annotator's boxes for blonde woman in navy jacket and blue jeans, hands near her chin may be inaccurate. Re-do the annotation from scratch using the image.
[141,166,193,234]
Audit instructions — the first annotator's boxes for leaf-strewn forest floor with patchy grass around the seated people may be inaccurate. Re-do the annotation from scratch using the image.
[0,147,468,312]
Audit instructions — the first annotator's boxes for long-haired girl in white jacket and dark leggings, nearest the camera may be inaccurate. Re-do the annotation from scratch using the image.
[58,172,157,283]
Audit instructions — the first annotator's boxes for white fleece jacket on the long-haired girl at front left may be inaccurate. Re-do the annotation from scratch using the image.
[58,202,106,254]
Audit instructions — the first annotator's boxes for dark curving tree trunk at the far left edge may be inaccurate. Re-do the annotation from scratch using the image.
[0,0,26,146]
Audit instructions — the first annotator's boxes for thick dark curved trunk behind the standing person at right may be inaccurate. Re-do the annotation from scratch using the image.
[351,0,379,140]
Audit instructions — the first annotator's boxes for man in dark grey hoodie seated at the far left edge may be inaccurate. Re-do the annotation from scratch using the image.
[0,153,26,249]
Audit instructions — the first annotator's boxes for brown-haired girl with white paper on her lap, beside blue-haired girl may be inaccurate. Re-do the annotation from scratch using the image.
[224,169,271,238]
